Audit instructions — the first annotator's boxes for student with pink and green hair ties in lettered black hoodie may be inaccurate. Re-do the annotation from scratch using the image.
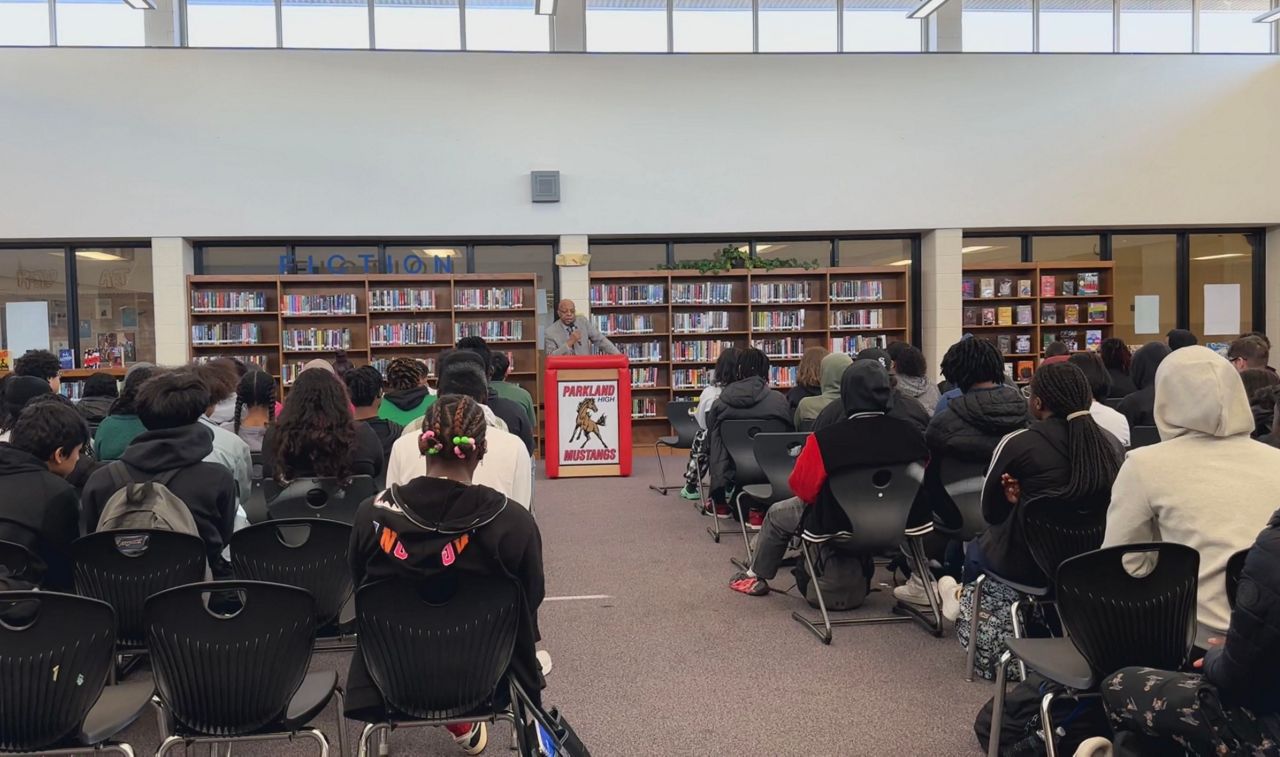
[347,397,545,754]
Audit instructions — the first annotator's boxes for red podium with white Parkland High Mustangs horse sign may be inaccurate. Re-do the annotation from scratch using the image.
[543,355,631,478]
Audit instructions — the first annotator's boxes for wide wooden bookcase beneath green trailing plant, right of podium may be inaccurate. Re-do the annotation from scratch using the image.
[590,266,910,447]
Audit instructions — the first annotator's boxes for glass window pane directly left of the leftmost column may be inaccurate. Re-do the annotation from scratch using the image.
[76,247,156,368]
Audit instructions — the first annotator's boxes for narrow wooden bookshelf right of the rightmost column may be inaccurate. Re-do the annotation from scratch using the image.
[961,261,1115,384]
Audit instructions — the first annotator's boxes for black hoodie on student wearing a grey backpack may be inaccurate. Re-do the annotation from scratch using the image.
[81,423,236,578]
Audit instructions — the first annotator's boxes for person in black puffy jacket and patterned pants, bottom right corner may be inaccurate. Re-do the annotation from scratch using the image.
[1098,511,1280,756]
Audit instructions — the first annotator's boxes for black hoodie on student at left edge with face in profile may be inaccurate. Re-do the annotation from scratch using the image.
[0,442,79,592]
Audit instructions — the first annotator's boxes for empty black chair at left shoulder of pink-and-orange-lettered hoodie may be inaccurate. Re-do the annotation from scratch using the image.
[230,517,356,652]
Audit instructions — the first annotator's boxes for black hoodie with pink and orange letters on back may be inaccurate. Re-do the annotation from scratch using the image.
[347,476,545,715]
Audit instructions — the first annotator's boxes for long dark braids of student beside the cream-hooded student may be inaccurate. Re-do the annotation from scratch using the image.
[1032,362,1121,500]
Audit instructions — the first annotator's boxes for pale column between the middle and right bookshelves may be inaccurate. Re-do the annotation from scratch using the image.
[920,229,964,379]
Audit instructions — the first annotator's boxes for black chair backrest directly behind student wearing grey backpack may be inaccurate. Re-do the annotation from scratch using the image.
[72,530,206,647]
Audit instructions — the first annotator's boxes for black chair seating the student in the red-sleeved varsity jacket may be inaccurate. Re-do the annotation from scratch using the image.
[791,462,942,644]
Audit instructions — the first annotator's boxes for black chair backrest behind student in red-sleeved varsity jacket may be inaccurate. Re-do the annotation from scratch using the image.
[805,462,924,553]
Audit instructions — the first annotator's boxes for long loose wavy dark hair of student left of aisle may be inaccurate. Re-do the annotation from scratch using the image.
[273,368,356,480]
